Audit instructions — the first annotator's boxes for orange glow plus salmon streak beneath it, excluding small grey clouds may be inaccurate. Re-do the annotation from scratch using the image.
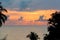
[5,10,57,25]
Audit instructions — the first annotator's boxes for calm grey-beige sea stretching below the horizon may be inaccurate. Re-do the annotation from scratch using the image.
[0,25,48,40]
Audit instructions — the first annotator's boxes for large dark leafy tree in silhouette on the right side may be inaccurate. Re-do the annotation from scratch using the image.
[44,12,60,40]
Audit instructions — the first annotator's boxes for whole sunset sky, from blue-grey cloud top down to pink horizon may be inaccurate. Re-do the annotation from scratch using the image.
[0,0,60,25]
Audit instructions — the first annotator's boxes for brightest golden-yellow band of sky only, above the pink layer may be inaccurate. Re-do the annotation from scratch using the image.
[3,10,56,21]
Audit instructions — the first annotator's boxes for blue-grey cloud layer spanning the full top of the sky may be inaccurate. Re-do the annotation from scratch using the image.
[0,0,60,10]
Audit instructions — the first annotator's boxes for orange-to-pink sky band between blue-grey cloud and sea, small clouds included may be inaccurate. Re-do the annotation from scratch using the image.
[4,10,56,25]
